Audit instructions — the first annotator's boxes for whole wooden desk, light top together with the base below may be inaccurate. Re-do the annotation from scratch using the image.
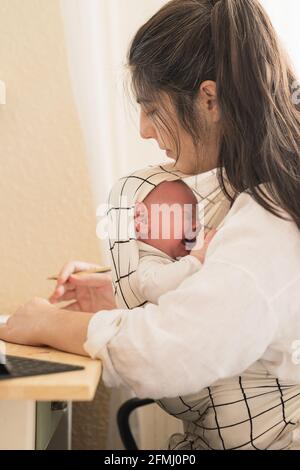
[0,344,101,450]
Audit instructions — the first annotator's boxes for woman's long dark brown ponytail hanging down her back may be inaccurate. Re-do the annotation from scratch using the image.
[211,0,300,228]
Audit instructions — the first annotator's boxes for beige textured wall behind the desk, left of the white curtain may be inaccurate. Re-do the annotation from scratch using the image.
[0,0,108,448]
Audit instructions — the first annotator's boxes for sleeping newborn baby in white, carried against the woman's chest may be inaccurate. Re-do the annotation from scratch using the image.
[135,180,216,304]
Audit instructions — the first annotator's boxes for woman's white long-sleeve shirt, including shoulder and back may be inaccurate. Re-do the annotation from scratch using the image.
[85,194,300,399]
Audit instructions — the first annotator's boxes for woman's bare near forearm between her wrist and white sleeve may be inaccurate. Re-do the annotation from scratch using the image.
[38,309,94,356]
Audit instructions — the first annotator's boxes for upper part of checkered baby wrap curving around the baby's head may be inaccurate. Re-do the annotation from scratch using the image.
[108,163,230,309]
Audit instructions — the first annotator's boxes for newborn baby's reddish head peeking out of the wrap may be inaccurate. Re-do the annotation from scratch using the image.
[135,180,200,259]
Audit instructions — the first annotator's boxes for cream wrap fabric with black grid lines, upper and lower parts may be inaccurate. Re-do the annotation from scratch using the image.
[108,165,300,450]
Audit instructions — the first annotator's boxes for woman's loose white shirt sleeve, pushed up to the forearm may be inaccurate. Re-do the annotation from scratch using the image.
[85,257,277,399]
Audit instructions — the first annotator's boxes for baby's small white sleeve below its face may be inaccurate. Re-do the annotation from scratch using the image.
[137,255,202,304]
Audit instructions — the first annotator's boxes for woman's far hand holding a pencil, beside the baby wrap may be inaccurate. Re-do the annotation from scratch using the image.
[49,261,117,313]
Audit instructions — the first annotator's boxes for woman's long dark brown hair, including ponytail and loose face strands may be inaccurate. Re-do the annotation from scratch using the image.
[128,0,300,229]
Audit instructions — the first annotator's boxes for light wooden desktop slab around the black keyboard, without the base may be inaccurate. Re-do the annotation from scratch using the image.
[0,344,101,401]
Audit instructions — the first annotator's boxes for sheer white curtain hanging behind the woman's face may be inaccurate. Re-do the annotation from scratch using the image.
[61,0,165,206]
